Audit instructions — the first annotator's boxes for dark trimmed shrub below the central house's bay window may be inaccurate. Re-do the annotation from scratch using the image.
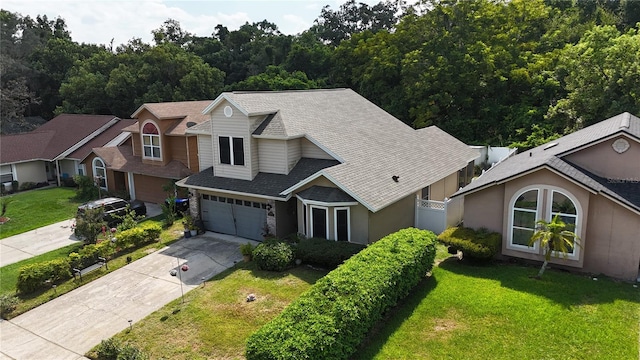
[295,238,366,269]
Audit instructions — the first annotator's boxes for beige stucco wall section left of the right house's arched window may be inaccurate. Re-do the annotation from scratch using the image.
[462,185,505,233]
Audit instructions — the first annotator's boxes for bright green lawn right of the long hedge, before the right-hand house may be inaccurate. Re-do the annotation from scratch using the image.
[356,259,640,360]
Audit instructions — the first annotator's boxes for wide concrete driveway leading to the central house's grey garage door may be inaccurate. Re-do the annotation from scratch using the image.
[0,233,255,359]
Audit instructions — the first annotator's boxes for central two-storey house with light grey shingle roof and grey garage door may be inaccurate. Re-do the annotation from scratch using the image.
[178,89,478,244]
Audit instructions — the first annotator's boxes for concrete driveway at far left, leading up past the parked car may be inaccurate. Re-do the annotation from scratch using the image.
[0,203,162,267]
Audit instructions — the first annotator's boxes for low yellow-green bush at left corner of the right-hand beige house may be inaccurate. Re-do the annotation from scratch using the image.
[438,227,502,260]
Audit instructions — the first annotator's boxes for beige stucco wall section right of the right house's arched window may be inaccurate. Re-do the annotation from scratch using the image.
[584,195,640,280]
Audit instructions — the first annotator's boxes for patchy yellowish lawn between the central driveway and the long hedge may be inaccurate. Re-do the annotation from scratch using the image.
[96,262,326,360]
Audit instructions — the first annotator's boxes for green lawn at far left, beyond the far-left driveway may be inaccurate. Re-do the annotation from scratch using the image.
[0,187,80,239]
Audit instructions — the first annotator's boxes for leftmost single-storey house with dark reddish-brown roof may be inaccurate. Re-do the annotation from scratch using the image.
[0,114,132,185]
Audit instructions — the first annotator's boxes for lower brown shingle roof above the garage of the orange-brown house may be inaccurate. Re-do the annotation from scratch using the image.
[93,146,192,179]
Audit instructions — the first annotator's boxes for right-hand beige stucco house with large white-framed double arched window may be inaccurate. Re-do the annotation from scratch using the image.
[454,113,640,280]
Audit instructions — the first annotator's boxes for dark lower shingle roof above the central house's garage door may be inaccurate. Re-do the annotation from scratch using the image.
[178,158,338,200]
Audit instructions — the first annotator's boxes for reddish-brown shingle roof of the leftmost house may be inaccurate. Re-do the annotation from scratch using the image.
[0,114,119,164]
